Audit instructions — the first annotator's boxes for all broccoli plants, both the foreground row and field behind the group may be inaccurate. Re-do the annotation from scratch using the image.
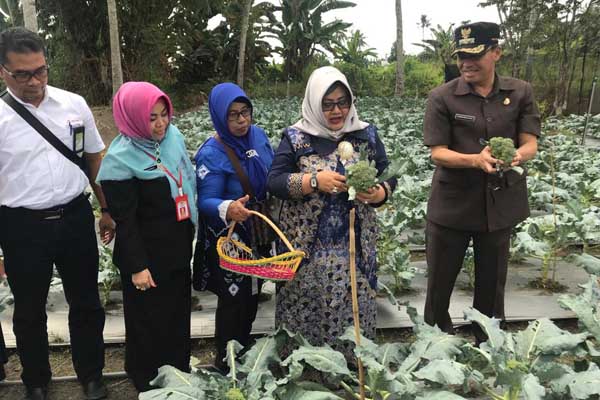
[132,98,600,400]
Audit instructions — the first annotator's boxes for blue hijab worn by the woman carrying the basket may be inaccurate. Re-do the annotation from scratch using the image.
[208,83,268,200]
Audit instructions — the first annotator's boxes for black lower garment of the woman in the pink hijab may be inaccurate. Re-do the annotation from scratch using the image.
[121,268,192,392]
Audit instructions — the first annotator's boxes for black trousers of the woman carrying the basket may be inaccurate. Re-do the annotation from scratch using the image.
[215,284,261,369]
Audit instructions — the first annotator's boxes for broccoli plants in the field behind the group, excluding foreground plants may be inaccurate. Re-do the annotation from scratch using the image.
[175,98,600,292]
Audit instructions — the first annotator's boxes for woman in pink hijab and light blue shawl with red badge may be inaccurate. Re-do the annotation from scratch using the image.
[97,82,197,391]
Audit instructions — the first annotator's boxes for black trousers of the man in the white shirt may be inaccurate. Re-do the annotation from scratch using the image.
[0,196,104,387]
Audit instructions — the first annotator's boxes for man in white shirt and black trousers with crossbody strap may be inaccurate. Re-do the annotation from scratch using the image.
[0,28,114,400]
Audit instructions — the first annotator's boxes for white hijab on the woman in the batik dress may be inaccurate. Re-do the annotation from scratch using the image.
[292,67,369,141]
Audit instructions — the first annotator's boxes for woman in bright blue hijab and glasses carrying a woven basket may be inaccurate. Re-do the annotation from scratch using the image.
[194,83,273,370]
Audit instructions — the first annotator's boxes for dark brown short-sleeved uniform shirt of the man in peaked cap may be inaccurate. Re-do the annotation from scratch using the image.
[423,76,540,232]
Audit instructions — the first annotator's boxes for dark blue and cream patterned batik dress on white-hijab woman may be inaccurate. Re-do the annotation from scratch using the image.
[268,125,395,358]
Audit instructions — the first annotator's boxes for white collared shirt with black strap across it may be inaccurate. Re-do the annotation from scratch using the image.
[0,86,104,210]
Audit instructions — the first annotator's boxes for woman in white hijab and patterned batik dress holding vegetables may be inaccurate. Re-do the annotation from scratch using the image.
[267,67,396,360]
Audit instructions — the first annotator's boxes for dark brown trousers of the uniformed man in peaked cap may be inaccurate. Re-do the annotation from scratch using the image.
[425,221,511,341]
